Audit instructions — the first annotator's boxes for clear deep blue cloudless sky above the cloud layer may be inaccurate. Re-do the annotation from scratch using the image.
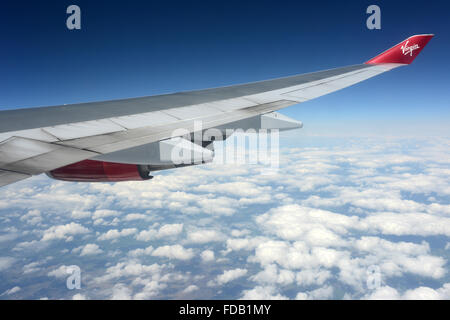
[0,1,450,135]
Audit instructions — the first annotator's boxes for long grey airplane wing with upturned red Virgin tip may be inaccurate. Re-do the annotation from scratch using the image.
[0,34,433,186]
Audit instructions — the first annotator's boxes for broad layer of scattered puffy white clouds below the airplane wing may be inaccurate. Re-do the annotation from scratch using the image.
[0,136,450,299]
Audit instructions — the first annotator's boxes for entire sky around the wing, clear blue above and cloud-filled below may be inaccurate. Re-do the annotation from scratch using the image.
[0,1,450,299]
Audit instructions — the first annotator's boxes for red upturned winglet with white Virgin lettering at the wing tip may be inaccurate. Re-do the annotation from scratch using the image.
[366,34,434,64]
